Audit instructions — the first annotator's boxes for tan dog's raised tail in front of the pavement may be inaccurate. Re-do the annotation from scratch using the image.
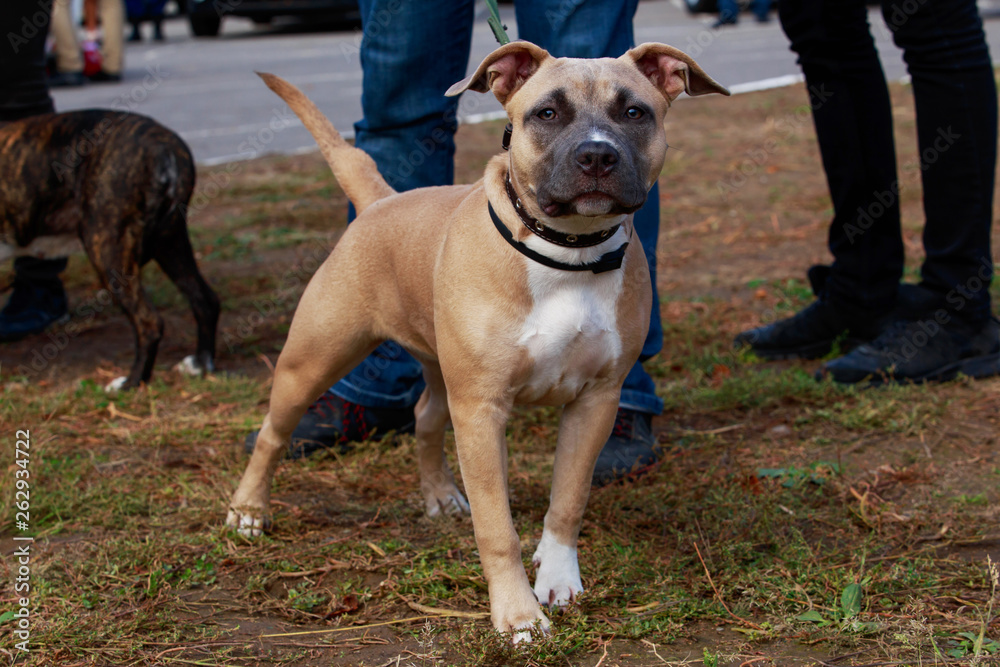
[257,72,396,213]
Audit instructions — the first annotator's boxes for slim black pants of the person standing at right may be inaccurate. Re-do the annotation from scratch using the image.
[778,0,997,323]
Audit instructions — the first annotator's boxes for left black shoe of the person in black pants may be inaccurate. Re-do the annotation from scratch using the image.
[733,299,883,361]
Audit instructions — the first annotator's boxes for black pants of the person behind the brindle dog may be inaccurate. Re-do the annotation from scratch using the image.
[0,0,66,289]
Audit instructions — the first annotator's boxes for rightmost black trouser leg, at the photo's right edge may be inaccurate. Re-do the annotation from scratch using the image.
[882,0,997,325]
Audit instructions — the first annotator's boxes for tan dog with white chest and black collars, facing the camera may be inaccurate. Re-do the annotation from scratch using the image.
[227,42,729,641]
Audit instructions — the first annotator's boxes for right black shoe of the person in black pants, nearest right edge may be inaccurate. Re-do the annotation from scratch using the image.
[816,317,1000,384]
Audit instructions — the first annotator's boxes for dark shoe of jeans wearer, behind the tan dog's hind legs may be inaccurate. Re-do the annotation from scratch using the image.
[244,391,416,459]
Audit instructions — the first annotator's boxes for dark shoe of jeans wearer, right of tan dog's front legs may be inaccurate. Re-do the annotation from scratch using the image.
[591,408,662,486]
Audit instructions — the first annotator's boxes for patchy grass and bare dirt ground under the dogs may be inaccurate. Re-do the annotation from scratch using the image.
[0,79,1000,667]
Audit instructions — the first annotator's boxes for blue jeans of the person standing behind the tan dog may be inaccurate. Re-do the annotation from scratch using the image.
[331,0,663,414]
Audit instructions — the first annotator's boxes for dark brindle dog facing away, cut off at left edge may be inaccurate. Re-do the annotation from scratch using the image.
[0,109,219,391]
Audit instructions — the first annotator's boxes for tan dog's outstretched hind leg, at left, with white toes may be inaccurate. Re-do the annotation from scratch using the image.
[226,260,382,536]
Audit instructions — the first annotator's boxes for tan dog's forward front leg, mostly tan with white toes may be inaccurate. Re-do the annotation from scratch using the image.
[449,396,549,643]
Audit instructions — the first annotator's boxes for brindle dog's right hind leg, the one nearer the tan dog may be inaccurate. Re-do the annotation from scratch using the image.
[153,209,219,375]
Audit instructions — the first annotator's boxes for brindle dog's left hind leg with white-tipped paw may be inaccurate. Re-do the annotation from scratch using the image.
[83,233,163,392]
